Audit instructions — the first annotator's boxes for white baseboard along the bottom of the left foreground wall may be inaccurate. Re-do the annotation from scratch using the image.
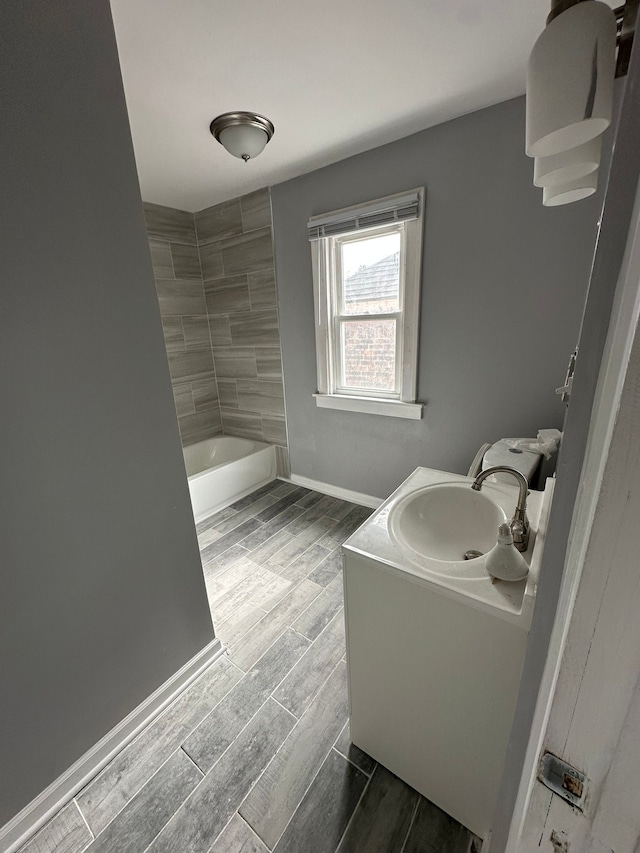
[0,637,223,853]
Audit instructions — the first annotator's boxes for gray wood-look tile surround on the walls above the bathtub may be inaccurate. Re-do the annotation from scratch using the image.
[144,188,289,476]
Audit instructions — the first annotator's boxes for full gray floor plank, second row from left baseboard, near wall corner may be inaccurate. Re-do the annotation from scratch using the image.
[182,628,309,773]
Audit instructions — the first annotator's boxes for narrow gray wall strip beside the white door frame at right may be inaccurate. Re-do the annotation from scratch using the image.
[491,55,640,853]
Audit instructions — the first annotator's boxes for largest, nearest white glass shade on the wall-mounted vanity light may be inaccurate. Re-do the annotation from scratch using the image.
[526,0,616,157]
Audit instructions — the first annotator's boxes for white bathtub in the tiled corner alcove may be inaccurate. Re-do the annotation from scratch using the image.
[182,435,276,522]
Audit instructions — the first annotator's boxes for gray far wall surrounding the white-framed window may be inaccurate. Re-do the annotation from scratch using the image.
[271,98,599,497]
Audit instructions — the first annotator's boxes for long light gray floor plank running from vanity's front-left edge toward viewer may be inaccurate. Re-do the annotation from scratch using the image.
[239,663,348,849]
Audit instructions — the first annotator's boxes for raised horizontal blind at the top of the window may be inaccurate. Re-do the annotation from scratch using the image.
[307,190,420,240]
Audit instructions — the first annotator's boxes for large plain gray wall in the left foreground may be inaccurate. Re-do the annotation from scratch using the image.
[0,0,213,824]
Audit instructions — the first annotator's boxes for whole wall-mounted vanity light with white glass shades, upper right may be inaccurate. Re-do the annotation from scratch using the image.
[526,0,639,207]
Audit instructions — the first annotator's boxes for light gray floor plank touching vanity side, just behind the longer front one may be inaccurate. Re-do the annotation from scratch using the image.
[273,611,345,717]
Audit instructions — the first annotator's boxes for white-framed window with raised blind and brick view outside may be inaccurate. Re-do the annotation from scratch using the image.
[308,189,424,419]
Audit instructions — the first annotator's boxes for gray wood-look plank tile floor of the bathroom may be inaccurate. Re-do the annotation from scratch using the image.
[21,480,480,853]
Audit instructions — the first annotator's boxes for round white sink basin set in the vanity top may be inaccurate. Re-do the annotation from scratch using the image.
[388,483,507,574]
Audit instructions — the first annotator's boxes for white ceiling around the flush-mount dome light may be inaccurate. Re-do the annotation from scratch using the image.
[111,0,549,210]
